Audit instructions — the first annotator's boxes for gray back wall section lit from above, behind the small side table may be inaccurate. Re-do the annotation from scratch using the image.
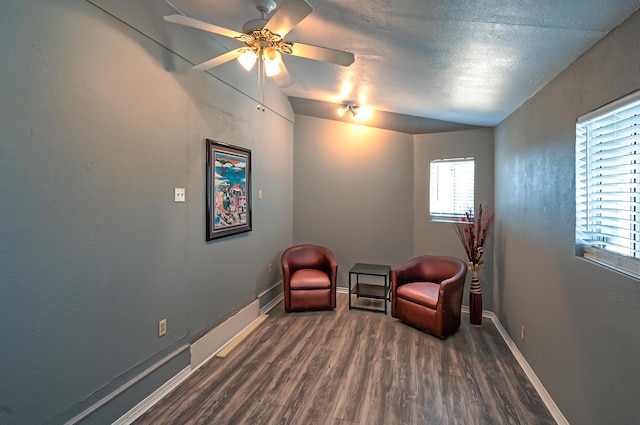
[293,115,413,287]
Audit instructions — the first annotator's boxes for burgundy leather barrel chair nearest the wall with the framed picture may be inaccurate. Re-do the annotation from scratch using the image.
[281,244,338,311]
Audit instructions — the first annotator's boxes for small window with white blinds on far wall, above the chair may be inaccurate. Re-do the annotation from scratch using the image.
[429,158,475,221]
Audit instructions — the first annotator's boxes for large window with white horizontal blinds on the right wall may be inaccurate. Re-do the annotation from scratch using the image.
[576,91,640,278]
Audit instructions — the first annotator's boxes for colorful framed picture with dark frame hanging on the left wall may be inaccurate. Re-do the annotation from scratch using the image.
[207,139,251,241]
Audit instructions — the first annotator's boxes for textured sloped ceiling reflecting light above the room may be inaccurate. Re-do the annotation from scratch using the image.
[94,0,640,133]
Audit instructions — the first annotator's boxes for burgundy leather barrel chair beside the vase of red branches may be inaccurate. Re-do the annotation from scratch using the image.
[391,255,467,338]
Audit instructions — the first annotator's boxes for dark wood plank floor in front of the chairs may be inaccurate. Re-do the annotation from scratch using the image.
[134,294,555,425]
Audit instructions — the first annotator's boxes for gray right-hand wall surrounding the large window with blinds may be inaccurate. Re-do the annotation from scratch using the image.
[494,9,640,425]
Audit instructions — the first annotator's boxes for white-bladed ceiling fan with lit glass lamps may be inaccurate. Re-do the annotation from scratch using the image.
[164,0,354,87]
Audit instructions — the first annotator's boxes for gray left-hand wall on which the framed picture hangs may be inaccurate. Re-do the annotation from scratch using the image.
[0,0,293,424]
